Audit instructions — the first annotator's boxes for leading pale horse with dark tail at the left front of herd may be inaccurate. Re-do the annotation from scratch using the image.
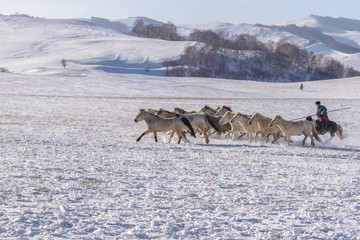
[134,109,195,143]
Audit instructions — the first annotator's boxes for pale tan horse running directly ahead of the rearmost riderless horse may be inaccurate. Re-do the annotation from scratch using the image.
[248,112,282,143]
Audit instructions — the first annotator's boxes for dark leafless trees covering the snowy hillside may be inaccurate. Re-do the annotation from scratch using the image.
[133,20,360,81]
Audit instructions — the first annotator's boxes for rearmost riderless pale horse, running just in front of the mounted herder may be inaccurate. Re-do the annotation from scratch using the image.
[269,115,320,146]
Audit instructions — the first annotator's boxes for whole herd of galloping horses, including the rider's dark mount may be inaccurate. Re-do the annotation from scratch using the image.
[134,105,343,146]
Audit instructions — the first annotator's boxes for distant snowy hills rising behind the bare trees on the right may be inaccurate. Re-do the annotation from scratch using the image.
[179,15,360,69]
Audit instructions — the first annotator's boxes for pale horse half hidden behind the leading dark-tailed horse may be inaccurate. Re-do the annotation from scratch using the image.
[156,109,221,144]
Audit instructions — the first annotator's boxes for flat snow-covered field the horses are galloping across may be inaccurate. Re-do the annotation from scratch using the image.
[0,69,360,239]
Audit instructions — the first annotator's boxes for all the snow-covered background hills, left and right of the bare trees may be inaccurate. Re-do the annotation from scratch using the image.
[0,15,360,75]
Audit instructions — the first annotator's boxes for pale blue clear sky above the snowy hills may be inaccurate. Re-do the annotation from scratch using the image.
[0,0,360,24]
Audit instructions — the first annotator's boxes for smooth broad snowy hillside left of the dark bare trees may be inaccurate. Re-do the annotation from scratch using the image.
[0,16,189,73]
